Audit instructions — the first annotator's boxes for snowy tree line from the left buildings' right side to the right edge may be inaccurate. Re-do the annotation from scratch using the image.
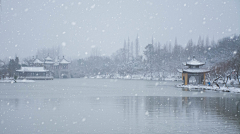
[72,35,240,77]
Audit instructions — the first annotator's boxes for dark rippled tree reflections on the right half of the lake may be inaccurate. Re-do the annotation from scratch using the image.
[116,96,240,133]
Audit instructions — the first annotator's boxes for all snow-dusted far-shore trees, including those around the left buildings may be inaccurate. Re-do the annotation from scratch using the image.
[0,35,240,80]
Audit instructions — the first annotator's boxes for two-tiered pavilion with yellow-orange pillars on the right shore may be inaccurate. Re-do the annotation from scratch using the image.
[178,56,209,85]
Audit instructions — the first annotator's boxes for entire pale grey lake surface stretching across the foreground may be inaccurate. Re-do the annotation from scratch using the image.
[0,79,240,134]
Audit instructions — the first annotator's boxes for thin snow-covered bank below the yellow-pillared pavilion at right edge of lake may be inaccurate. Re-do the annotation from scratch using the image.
[176,85,240,93]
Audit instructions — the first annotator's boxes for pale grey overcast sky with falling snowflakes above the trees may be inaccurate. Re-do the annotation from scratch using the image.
[0,0,240,58]
